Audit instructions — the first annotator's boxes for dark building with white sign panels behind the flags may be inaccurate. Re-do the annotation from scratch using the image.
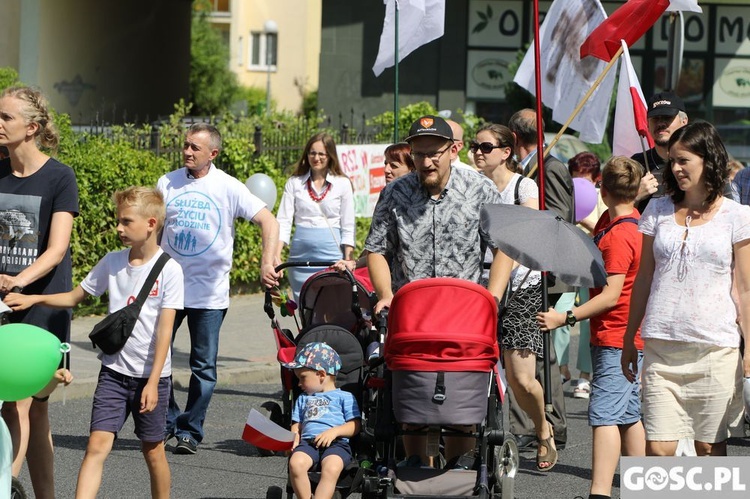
[319,0,750,135]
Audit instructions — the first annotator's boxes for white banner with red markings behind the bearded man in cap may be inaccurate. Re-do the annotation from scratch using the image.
[336,144,388,217]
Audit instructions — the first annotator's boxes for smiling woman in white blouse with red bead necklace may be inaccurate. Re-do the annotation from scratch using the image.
[276,133,354,301]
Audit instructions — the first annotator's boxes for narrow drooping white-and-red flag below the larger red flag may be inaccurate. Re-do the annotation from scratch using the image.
[612,40,654,157]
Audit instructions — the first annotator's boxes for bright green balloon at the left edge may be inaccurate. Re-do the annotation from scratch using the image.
[0,324,62,402]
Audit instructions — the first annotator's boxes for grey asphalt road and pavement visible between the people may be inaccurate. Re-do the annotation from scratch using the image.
[10,295,750,499]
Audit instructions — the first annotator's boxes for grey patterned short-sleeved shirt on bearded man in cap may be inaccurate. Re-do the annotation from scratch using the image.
[365,168,501,292]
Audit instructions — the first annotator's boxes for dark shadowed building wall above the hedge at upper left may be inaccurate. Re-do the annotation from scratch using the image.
[0,0,191,125]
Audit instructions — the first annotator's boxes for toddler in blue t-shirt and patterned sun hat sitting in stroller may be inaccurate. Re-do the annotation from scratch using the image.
[283,342,360,498]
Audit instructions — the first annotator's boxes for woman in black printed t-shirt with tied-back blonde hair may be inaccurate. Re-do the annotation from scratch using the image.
[0,87,78,498]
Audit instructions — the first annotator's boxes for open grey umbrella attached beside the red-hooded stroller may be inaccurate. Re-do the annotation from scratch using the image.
[481,204,607,288]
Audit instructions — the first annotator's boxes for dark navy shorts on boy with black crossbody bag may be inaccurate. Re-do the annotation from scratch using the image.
[90,366,171,443]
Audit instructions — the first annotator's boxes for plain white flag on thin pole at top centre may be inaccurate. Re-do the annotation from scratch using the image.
[372,0,445,76]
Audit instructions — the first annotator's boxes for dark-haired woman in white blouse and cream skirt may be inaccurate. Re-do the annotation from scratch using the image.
[622,123,750,456]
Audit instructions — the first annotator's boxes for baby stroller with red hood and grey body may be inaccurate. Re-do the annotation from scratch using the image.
[363,278,518,499]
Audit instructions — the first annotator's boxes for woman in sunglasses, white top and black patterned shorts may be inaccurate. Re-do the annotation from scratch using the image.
[476,124,557,471]
